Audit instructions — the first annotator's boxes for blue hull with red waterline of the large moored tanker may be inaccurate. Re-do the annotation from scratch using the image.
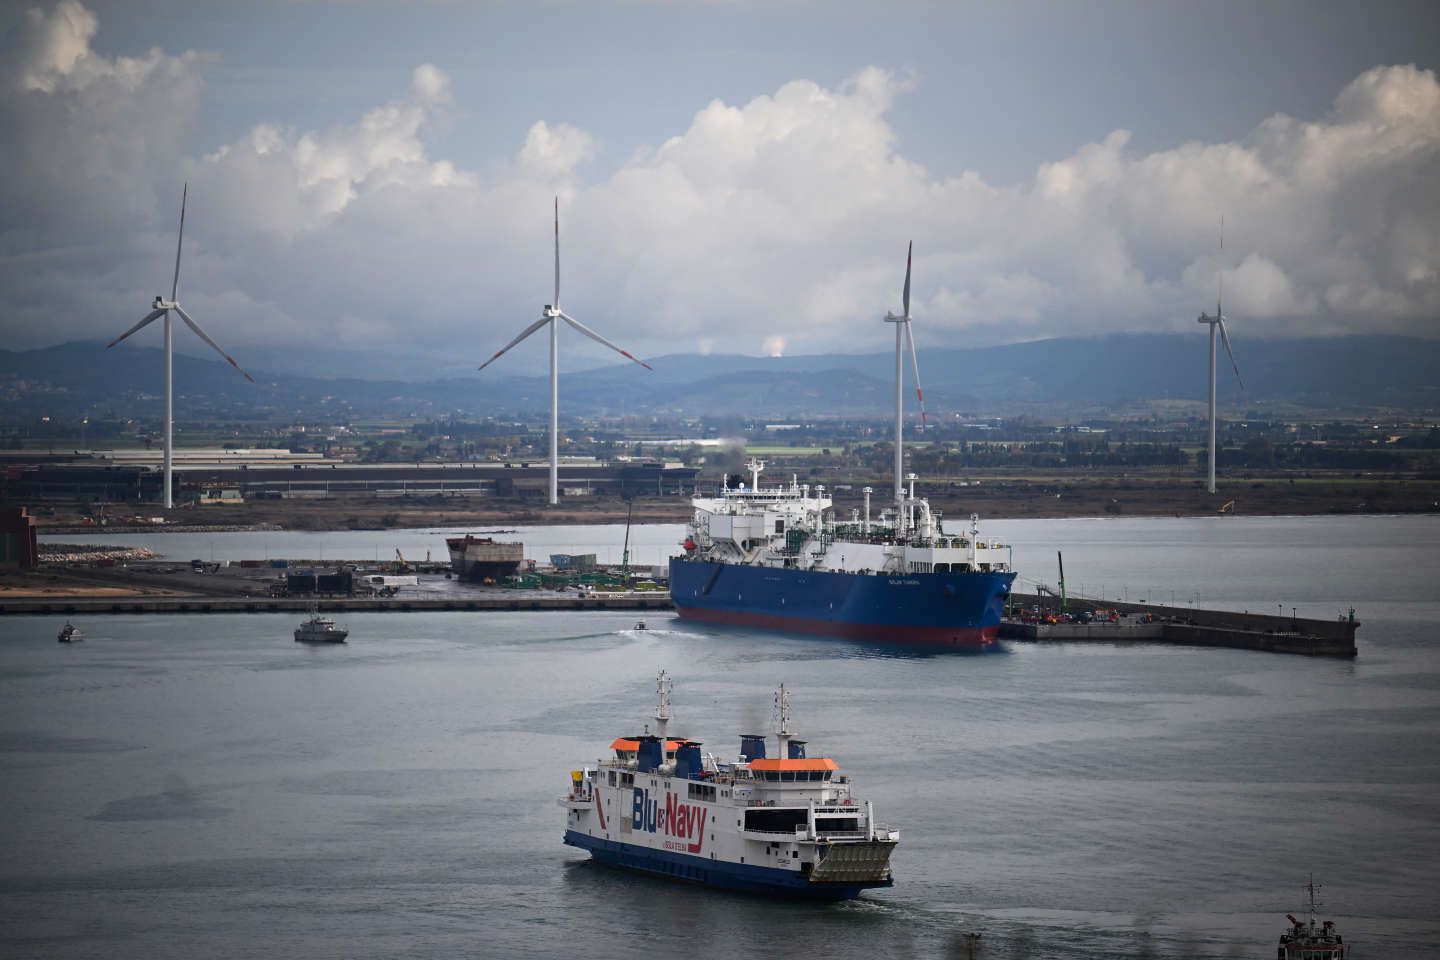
[670,557,1015,649]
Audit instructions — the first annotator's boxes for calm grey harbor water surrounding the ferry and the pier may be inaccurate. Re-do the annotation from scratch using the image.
[0,517,1440,960]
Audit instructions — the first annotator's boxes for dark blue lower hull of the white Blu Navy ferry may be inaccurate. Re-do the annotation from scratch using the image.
[564,830,894,900]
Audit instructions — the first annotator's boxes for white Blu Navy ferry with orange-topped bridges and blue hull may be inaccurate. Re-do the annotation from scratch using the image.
[559,671,900,901]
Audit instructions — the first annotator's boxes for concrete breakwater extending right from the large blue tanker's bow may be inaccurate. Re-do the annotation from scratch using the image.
[1001,593,1359,656]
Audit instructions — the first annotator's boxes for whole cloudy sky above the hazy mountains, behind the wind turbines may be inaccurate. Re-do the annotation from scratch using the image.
[0,0,1440,371]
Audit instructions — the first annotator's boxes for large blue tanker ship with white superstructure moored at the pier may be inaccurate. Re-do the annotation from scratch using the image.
[670,461,1015,649]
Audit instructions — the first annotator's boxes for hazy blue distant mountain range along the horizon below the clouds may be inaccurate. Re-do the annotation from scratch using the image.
[0,334,1440,422]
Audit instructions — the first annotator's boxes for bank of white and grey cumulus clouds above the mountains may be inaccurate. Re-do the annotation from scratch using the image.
[0,0,1440,361]
